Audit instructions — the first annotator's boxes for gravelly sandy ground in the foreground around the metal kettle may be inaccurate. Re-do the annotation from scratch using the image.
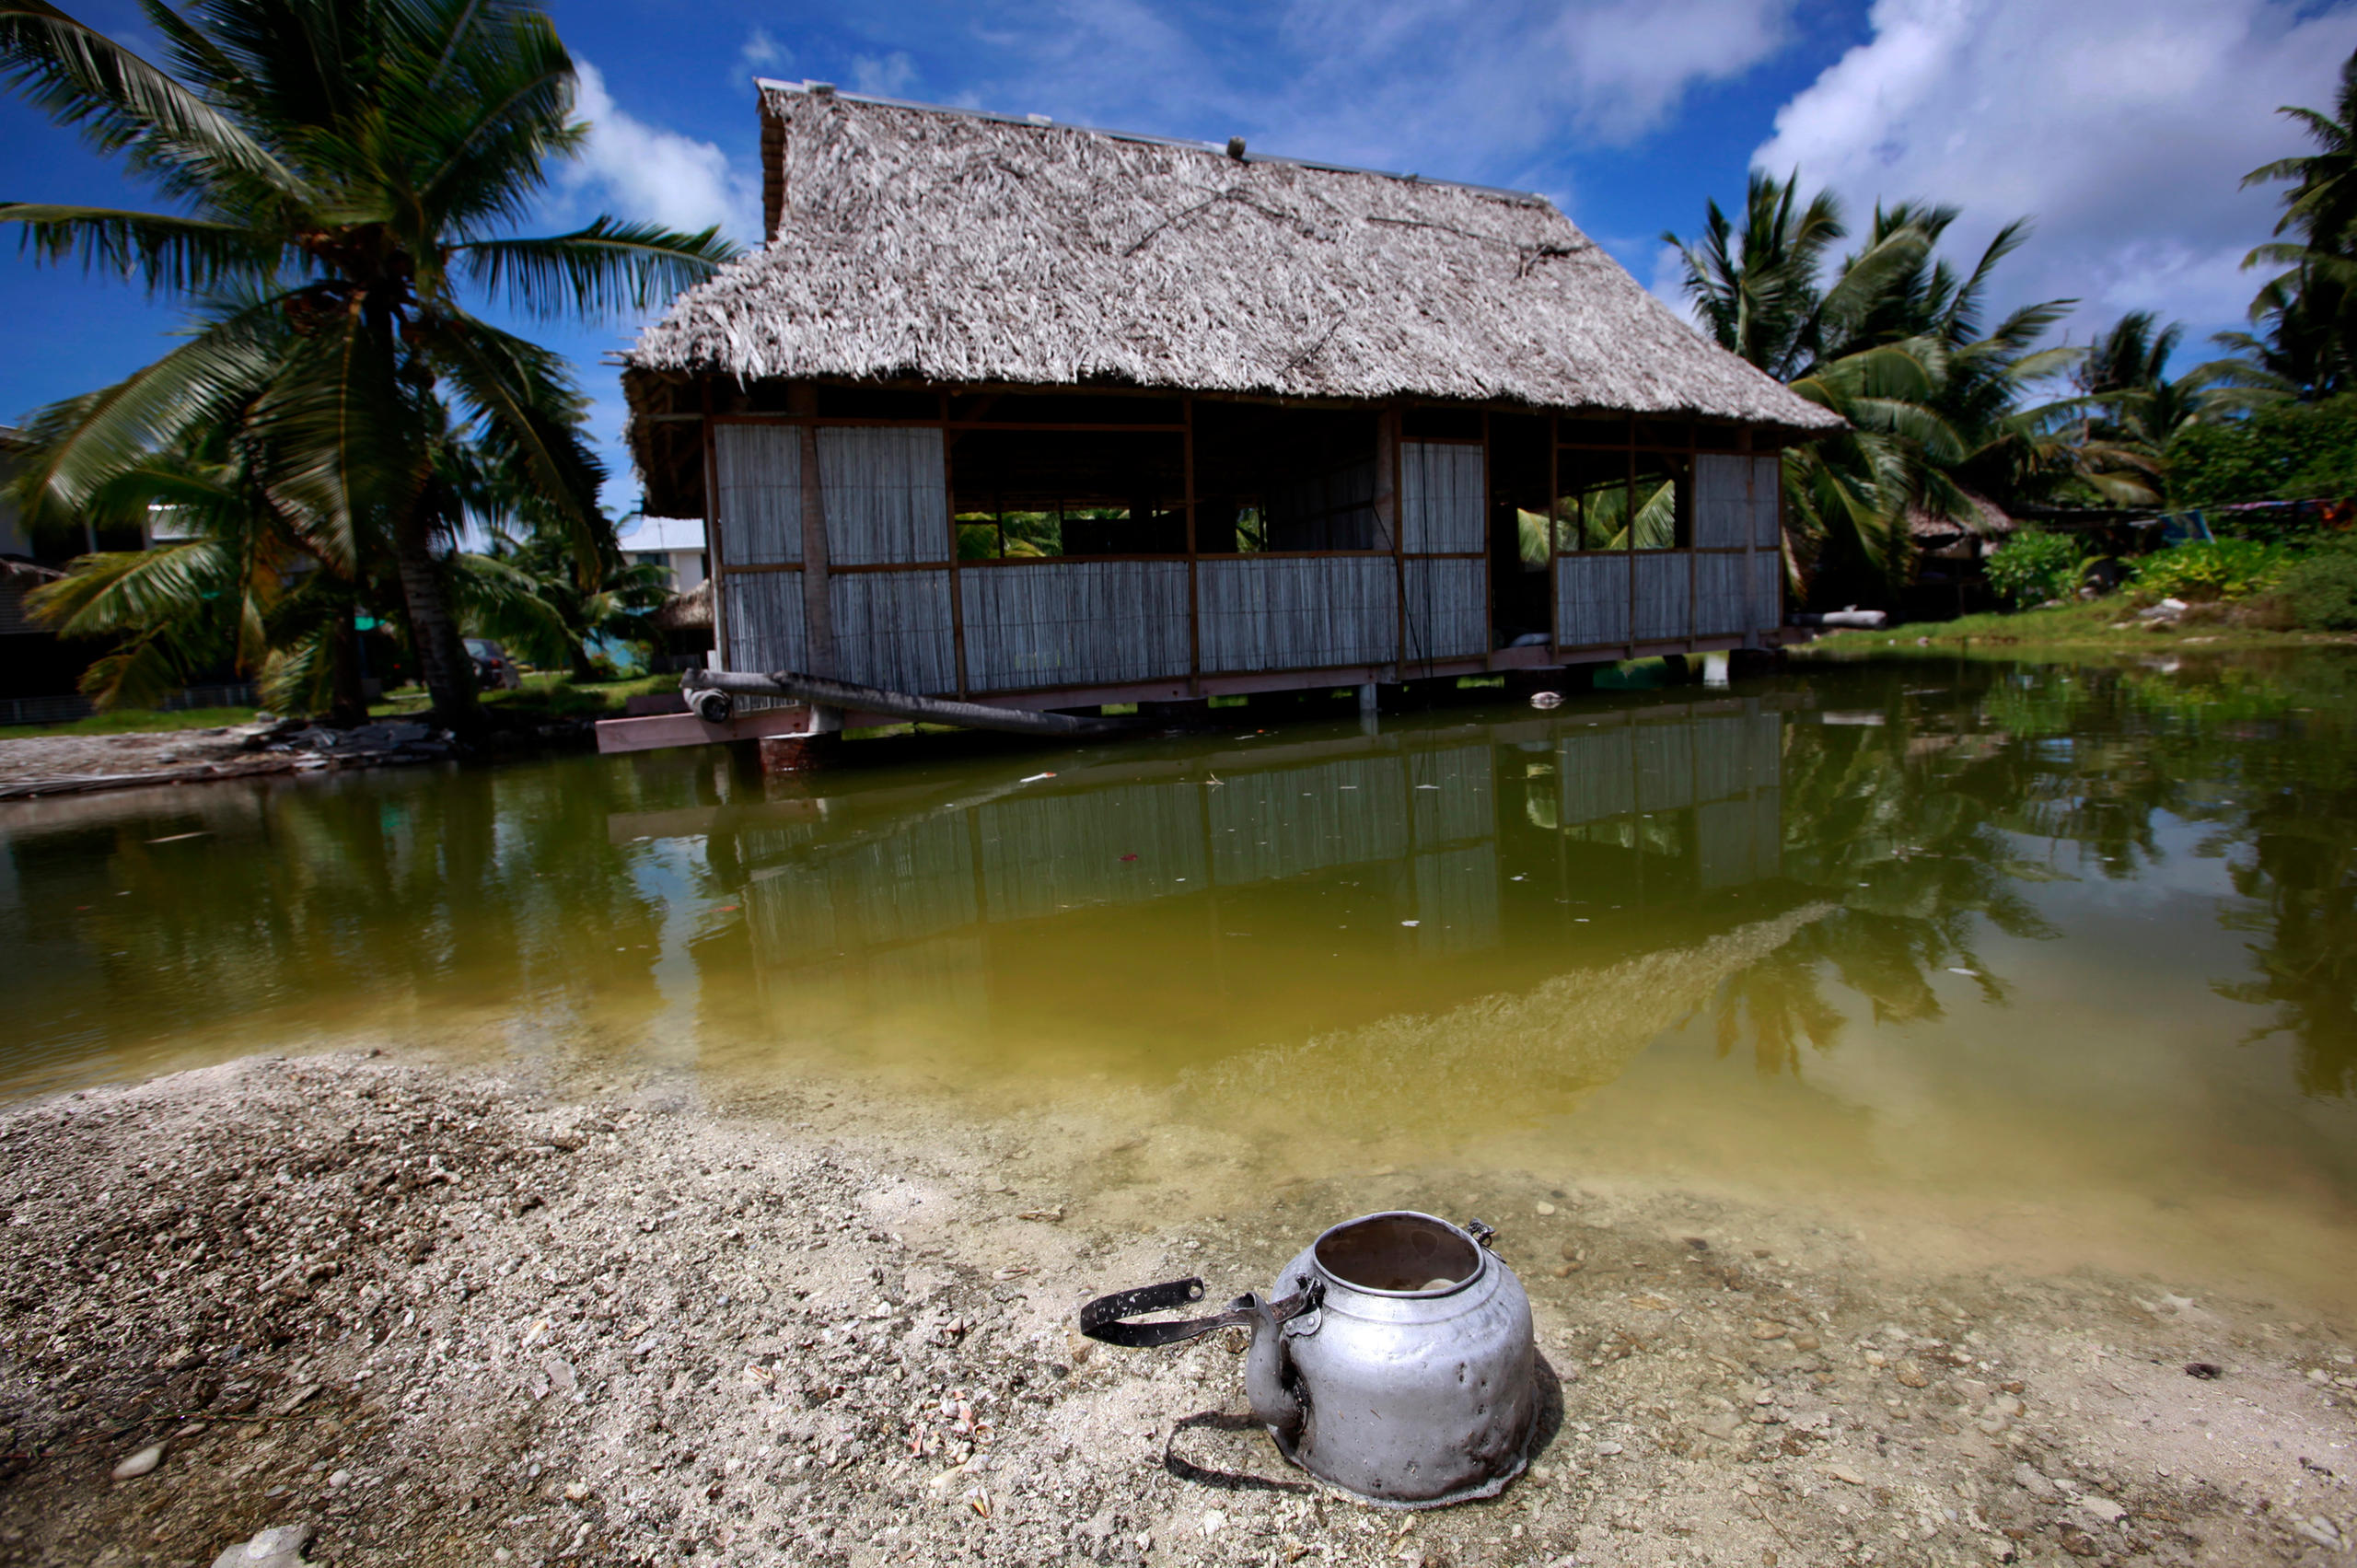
[0,1054,2357,1568]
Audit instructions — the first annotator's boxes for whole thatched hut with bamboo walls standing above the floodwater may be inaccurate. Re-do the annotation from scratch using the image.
[624,83,1839,726]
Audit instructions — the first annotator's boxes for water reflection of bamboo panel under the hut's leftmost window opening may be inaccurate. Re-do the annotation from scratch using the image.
[967,783,1212,922]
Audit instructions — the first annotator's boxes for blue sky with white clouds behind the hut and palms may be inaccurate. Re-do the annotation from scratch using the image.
[0,0,2357,526]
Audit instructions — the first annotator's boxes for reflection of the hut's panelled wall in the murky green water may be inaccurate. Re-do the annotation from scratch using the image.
[692,701,1780,1018]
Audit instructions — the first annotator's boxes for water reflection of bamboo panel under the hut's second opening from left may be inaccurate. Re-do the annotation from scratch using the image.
[1204,757,1410,887]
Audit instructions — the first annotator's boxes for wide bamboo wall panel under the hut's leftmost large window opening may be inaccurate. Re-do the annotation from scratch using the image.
[957,561,1188,691]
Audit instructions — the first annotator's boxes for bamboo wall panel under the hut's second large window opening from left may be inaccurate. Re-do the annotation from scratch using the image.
[1195,556,1400,674]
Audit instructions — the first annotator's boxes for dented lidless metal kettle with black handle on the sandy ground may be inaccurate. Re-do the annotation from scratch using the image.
[1079,1210,1539,1509]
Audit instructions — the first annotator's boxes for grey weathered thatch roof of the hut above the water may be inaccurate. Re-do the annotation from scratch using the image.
[630,83,1839,432]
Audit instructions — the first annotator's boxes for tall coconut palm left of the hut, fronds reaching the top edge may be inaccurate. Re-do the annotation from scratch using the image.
[0,0,731,726]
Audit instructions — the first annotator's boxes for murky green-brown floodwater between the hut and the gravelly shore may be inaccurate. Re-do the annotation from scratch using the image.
[0,656,2357,1311]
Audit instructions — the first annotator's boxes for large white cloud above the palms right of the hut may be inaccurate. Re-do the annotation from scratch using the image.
[1754,0,2357,346]
